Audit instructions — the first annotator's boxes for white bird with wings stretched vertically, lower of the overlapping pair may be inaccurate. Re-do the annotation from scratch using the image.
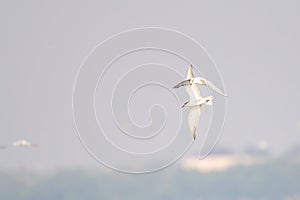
[174,65,212,140]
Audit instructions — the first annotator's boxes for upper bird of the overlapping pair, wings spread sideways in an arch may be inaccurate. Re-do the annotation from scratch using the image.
[174,65,227,97]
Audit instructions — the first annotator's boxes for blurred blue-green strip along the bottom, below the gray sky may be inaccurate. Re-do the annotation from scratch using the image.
[0,159,300,200]
